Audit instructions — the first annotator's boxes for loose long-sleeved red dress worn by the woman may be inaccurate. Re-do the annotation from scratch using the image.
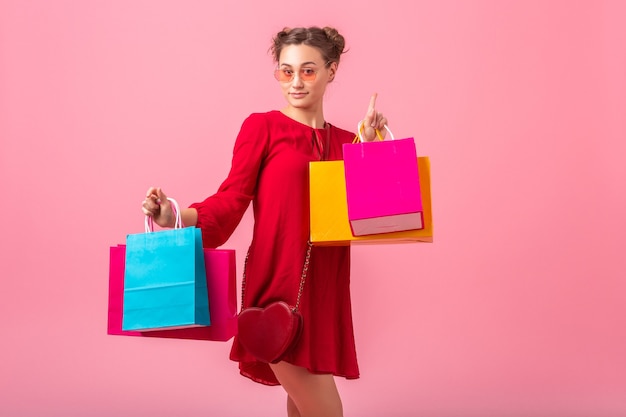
[191,111,359,385]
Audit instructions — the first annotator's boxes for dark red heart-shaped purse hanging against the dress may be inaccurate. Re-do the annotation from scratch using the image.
[237,301,302,363]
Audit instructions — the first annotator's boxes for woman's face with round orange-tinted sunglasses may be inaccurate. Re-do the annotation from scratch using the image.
[278,44,337,111]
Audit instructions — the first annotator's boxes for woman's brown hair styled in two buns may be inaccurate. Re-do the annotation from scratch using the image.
[270,26,346,64]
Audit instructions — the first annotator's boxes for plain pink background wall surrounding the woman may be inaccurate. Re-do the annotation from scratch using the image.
[0,0,626,417]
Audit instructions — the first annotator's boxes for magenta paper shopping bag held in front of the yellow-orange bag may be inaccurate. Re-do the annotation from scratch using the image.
[343,122,424,236]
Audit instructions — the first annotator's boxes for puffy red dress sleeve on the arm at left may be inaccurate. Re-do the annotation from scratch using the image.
[190,114,269,248]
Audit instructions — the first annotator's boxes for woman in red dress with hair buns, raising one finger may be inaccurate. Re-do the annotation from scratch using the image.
[143,27,387,417]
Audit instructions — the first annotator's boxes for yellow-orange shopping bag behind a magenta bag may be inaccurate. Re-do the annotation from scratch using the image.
[309,156,433,246]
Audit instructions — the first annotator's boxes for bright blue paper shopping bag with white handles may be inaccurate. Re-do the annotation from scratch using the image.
[122,199,211,331]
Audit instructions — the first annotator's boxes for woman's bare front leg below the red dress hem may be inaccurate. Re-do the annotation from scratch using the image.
[270,362,343,417]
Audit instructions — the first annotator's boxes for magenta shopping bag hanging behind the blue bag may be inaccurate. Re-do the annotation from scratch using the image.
[107,245,237,341]
